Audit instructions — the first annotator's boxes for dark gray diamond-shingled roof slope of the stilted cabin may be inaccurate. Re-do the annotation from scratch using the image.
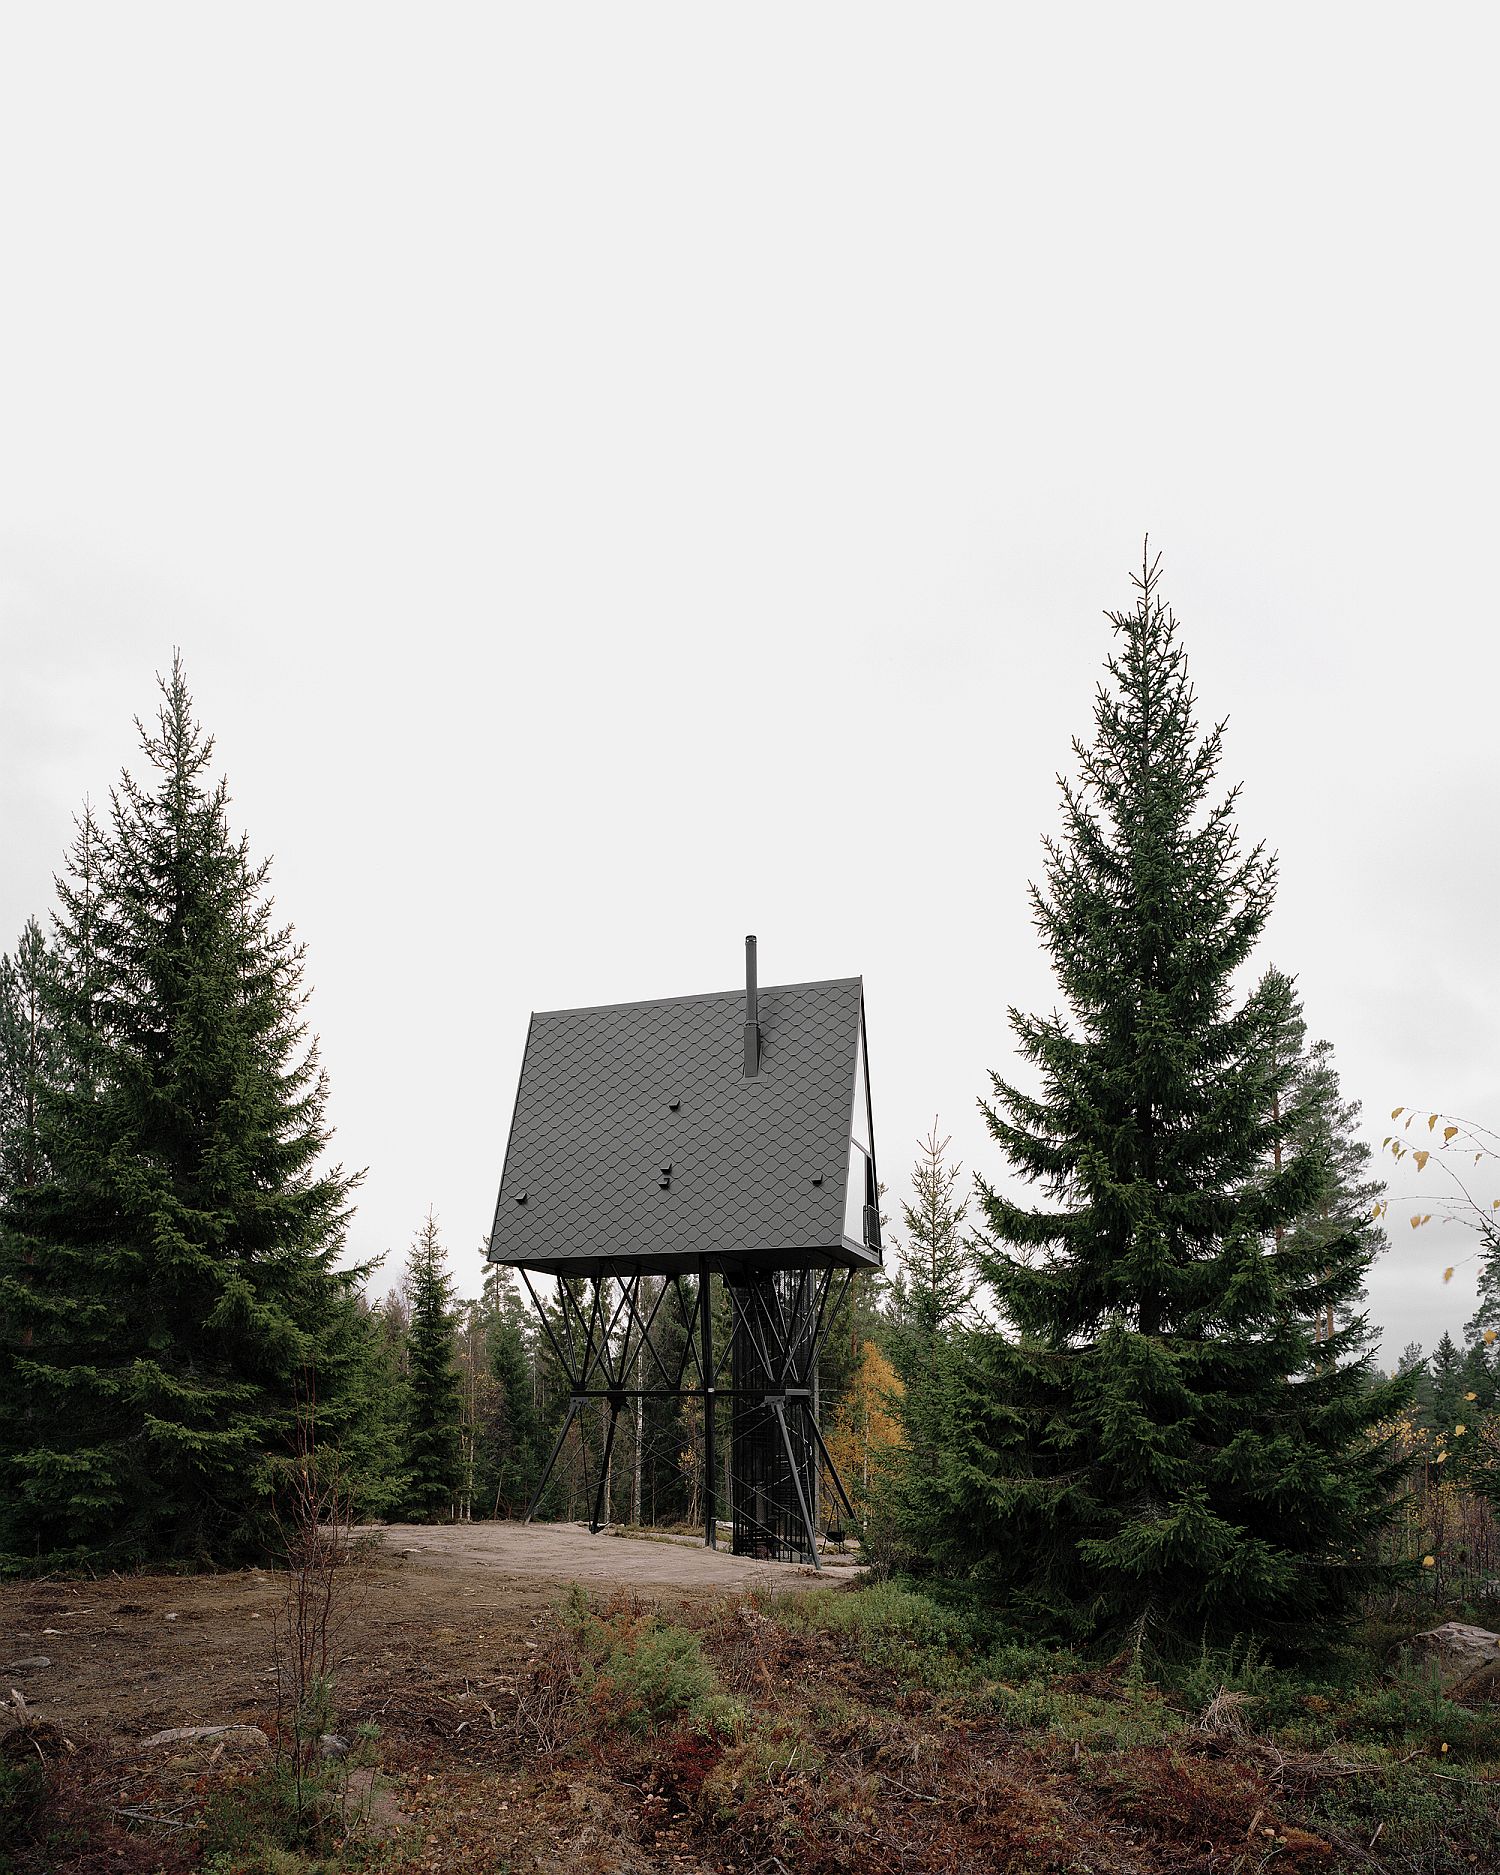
[489,977,876,1275]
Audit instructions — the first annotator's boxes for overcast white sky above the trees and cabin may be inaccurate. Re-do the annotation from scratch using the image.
[0,4,1500,1358]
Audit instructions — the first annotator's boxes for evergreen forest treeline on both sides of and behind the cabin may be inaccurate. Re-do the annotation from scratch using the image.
[0,563,1500,1650]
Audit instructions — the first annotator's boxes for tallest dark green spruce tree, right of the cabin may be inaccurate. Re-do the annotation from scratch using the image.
[919,547,1408,1652]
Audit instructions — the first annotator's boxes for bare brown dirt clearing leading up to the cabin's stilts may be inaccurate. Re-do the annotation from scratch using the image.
[0,1523,853,1875]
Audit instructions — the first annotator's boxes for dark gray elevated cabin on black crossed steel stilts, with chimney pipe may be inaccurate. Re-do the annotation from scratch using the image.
[488,938,881,1562]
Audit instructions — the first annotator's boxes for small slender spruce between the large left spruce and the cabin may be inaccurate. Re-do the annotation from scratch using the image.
[405,1211,463,1523]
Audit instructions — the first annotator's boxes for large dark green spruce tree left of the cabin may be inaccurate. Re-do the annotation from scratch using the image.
[0,658,373,1566]
